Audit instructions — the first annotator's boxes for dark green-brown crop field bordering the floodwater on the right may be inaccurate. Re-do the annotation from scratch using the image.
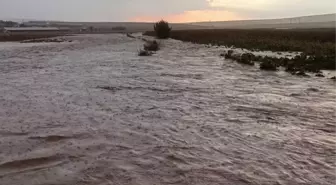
[145,29,336,77]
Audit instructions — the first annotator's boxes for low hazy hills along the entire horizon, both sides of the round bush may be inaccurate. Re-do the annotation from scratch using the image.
[4,13,336,32]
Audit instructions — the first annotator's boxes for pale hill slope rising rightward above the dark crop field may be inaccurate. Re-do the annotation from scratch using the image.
[190,14,336,28]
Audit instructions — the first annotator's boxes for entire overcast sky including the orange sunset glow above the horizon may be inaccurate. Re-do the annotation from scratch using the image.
[0,0,336,22]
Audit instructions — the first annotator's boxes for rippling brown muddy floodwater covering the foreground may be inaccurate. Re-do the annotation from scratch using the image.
[0,34,336,185]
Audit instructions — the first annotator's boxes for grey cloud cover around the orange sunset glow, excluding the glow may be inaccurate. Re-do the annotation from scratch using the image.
[0,0,336,21]
